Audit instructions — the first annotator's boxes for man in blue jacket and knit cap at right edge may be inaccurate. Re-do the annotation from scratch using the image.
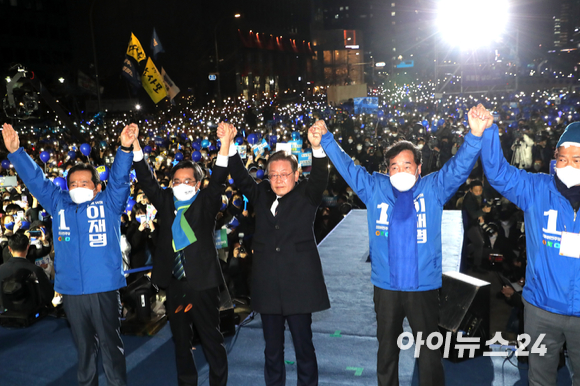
[477,106,580,385]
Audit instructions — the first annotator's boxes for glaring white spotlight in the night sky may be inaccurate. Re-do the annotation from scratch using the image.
[437,0,508,50]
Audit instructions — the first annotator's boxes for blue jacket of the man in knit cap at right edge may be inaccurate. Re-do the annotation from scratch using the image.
[481,125,580,316]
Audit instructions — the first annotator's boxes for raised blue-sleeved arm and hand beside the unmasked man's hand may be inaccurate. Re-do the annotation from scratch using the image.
[315,120,374,203]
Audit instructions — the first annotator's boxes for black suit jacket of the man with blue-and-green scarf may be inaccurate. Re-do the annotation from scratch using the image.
[134,160,228,291]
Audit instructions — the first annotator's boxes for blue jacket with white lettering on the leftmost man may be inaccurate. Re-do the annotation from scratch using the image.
[8,148,133,295]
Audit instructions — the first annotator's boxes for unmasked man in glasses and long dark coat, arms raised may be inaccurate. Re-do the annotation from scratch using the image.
[218,124,330,386]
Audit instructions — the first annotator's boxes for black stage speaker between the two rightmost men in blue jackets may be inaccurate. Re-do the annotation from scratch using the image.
[439,272,491,362]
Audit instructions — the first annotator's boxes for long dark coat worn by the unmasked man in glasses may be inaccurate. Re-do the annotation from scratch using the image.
[228,155,330,315]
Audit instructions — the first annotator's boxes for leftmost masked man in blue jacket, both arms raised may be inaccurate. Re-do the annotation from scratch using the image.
[2,124,138,386]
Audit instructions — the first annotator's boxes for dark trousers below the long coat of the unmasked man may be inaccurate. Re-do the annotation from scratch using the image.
[262,314,318,386]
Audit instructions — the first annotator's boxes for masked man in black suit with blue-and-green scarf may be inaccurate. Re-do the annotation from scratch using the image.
[134,126,233,386]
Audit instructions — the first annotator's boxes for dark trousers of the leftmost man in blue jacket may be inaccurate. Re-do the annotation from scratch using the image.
[63,291,127,386]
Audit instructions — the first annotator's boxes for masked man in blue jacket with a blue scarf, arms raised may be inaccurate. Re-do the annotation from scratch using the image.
[315,109,483,386]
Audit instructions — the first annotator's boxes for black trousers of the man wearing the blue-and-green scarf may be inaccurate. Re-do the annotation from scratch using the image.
[167,279,228,386]
